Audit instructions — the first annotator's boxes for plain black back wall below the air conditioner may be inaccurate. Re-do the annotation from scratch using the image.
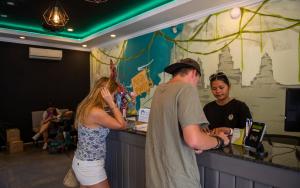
[0,42,90,142]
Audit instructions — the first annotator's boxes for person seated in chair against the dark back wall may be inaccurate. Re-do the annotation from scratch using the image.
[32,107,61,150]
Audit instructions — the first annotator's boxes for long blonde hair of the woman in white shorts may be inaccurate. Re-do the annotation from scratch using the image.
[75,77,118,129]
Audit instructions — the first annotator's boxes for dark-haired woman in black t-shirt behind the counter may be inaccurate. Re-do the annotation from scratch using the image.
[203,72,252,134]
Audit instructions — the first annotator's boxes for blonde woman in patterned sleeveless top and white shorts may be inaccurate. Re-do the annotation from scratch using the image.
[72,77,126,188]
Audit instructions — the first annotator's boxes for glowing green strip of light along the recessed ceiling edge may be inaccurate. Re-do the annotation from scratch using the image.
[0,0,175,40]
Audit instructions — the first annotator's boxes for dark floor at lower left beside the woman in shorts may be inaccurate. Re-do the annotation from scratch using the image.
[0,145,73,188]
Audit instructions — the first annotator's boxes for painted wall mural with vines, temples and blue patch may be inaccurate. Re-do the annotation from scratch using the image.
[91,0,300,135]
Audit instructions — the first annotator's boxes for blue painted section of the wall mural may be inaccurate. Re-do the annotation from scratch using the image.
[118,24,183,109]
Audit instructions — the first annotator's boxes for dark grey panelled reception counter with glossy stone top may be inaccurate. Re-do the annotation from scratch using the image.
[106,130,300,188]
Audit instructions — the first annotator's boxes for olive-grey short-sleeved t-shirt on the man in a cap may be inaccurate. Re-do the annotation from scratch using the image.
[146,82,203,188]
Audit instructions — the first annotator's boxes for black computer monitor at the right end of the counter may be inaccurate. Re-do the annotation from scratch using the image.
[284,88,300,132]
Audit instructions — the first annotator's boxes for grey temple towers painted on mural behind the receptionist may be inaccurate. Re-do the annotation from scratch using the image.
[199,48,285,134]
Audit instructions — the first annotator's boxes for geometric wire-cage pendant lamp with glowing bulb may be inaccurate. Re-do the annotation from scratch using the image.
[43,0,69,31]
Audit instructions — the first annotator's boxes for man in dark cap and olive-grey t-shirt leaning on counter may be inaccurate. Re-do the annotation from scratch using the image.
[146,58,229,188]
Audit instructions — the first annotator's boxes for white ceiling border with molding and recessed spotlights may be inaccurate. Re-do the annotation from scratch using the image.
[0,0,262,51]
